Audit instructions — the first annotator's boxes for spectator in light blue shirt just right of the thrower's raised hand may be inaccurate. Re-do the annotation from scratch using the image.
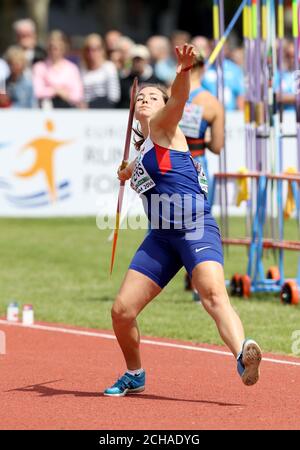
[202,44,245,111]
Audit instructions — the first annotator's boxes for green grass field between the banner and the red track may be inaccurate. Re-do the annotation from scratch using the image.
[0,218,300,354]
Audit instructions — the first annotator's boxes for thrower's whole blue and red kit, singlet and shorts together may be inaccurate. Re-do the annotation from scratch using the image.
[129,137,223,288]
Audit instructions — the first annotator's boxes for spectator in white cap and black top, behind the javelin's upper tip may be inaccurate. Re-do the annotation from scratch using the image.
[118,45,164,108]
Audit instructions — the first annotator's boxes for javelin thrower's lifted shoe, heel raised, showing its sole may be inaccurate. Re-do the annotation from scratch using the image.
[237,339,262,386]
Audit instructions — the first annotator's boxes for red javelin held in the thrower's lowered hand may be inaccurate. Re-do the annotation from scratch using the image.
[110,77,138,274]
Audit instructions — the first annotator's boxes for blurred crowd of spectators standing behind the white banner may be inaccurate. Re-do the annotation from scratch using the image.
[0,19,294,110]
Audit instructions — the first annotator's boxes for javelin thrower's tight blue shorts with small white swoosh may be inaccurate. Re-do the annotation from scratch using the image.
[129,224,224,288]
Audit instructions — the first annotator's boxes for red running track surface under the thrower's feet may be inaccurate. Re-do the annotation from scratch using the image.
[0,321,300,430]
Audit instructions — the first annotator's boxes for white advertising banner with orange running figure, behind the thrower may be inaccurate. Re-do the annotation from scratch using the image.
[0,110,296,217]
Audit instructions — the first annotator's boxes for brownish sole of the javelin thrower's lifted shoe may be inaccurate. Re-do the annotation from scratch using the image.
[242,341,262,386]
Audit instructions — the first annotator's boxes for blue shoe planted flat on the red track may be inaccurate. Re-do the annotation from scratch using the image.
[104,371,146,397]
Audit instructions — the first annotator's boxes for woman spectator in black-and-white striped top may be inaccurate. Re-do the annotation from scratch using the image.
[82,34,120,108]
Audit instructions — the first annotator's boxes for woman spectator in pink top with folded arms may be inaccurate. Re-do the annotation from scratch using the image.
[33,31,83,108]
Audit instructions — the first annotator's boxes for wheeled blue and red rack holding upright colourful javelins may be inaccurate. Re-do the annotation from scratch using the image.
[211,0,300,304]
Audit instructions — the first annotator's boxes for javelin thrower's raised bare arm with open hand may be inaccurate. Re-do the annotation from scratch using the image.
[150,44,195,133]
